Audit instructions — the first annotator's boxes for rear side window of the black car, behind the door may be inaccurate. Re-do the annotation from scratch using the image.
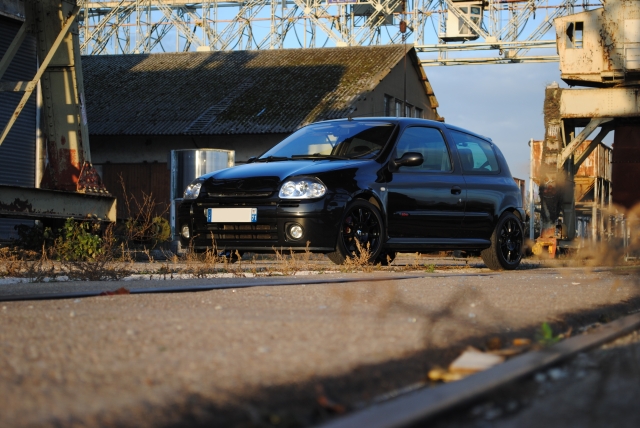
[451,131,500,174]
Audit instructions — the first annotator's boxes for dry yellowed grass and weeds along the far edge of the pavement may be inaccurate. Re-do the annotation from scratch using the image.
[0,199,640,282]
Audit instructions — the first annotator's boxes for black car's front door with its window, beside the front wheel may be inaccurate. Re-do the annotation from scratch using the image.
[387,126,466,243]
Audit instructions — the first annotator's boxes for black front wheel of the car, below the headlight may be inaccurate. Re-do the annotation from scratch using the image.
[327,199,384,265]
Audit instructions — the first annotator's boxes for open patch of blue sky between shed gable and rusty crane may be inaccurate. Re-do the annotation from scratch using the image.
[425,63,566,184]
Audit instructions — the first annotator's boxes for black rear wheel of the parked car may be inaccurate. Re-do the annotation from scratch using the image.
[480,212,524,270]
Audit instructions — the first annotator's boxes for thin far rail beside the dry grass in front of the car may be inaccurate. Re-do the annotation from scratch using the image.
[0,273,496,302]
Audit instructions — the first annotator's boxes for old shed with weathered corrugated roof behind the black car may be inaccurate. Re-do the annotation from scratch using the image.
[82,45,443,218]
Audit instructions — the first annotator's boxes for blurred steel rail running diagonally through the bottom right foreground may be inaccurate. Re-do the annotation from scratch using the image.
[317,313,640,428]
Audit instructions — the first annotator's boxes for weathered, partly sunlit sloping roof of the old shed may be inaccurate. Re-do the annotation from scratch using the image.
[82,45,428,135]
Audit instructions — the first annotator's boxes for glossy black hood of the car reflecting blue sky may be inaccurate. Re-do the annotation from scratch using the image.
[202,159,372,196]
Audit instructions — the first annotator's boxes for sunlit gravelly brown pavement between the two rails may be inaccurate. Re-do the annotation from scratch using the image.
[0,262,640,427]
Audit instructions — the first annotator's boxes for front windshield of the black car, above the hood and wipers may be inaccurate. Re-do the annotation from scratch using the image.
[258,121,395,162]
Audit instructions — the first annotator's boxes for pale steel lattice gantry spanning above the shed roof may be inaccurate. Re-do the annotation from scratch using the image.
[78,0,601,66]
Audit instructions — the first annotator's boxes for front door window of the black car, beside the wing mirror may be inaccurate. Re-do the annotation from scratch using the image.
[396,126,451,172]
